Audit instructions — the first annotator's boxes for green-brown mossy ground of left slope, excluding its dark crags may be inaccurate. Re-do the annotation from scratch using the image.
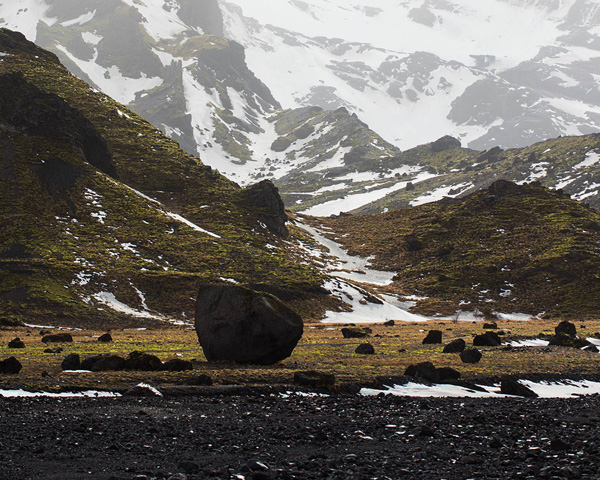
[0,31,328,326]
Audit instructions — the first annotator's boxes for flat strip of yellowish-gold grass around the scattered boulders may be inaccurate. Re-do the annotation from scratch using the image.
[0,320,600,391]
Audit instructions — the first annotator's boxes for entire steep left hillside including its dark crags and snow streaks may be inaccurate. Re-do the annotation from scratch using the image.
[0,30,326,327]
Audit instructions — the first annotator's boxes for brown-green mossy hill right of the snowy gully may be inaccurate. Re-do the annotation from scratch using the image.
[320,182,600,318]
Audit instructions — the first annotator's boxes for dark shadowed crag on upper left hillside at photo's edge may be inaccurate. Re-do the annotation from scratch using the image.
[0,73,117,178]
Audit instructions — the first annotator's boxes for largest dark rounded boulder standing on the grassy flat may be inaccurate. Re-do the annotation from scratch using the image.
[196,284,304,365]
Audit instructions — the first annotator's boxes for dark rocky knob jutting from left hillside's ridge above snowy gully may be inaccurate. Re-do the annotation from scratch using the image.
[240,180,290,238]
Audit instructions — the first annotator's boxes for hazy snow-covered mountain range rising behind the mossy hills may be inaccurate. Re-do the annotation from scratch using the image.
[0,0,600,215]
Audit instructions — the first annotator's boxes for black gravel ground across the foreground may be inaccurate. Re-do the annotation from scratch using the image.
[0,393,600,480]
